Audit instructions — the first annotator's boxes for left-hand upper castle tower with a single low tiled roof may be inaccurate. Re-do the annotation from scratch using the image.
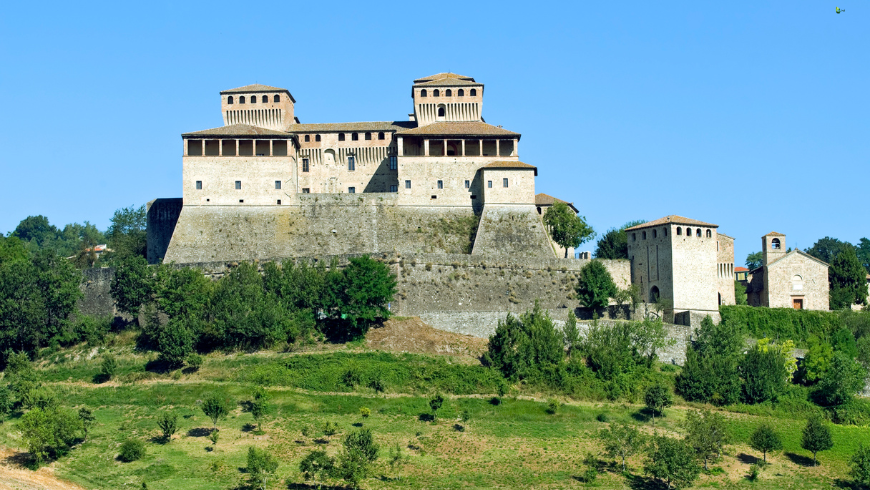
[221,84,296,131]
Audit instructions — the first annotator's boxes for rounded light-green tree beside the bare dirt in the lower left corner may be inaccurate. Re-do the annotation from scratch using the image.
[18,407,82,465]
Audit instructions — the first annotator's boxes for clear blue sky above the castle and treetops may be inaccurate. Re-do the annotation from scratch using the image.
[0,0,870,265]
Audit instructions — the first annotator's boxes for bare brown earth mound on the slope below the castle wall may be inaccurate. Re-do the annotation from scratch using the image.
[366,316,488,362]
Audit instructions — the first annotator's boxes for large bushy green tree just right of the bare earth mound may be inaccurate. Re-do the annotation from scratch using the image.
[484,302,565,379]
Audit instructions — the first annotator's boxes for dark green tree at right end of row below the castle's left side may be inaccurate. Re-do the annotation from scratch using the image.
[341,255,396,334]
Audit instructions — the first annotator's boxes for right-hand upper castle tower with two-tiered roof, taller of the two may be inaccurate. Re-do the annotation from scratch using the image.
[411,73,483,126]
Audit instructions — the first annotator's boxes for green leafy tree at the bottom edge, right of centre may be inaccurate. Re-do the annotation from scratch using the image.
[644,435,701,489]
